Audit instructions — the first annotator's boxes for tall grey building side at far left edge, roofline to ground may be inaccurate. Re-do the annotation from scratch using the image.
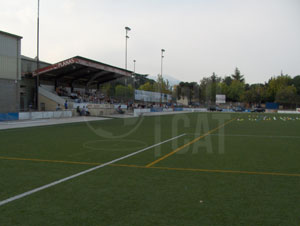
[0,31,22,113]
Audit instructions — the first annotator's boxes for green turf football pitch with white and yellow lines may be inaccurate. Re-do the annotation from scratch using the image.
[0,113,300,226]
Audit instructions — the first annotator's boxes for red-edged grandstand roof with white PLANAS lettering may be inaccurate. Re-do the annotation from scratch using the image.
[33,56,133,85]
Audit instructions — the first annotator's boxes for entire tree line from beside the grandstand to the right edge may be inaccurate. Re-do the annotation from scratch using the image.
[102,68,300,106]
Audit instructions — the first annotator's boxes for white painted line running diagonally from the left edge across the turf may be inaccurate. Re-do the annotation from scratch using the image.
[0,133,185,206]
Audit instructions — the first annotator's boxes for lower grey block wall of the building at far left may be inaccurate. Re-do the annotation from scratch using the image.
[0,79,20,113]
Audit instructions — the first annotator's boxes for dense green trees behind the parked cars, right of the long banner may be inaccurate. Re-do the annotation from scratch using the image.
[173,68,300,105]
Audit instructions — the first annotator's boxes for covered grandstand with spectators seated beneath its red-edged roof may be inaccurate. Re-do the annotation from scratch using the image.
[32,56,132,116]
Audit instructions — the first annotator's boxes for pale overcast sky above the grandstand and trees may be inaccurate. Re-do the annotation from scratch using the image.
[0,0,300,83]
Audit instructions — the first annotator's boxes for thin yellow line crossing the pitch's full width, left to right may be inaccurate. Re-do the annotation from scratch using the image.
[0,156,300,177]
